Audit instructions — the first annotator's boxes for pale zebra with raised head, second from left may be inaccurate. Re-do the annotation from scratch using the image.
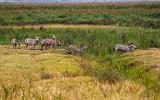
[25,36,39,49]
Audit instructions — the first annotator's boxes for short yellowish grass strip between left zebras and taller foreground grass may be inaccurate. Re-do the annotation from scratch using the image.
[0,46,80,73]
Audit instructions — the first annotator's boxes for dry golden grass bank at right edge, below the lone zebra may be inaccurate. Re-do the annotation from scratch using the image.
[127,48,160,78]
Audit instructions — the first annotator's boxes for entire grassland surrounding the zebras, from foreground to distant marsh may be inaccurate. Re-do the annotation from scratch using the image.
[0,3,160,100]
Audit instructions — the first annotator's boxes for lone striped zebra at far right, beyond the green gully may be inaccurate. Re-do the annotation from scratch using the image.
[114,43,137,52]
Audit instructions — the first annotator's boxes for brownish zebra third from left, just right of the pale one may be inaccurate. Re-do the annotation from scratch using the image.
[41,38,62,50]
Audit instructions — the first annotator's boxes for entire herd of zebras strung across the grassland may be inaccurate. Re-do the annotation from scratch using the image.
[11,36,137,54]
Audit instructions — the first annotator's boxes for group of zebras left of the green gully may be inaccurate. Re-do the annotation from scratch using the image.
[11,36,87,54]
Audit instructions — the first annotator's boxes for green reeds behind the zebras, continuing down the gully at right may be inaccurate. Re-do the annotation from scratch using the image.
[0,27,160,94]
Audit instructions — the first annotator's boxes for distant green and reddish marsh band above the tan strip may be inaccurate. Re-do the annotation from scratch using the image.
[0,2,160,28]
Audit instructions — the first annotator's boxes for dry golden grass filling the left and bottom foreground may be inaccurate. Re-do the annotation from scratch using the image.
[0,46,158,100]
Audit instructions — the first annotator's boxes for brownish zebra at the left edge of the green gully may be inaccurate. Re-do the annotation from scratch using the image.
[68,44,87,54]
